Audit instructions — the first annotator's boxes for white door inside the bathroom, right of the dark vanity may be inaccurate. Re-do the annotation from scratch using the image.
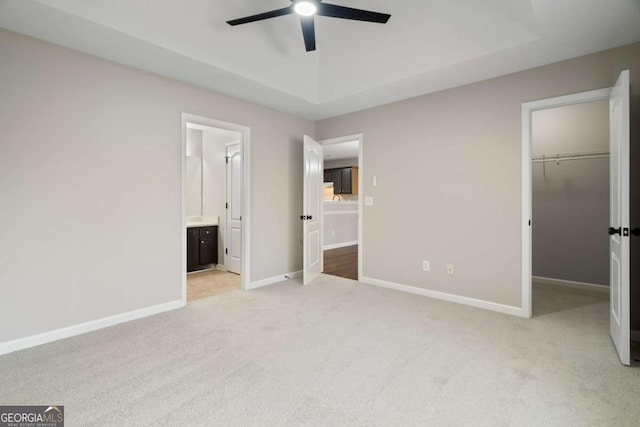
[224,142,242,274]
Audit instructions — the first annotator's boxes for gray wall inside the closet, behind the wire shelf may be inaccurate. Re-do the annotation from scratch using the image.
[532,100,609,285]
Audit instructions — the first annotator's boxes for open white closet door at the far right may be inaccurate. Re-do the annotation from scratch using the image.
[609,70,631,365]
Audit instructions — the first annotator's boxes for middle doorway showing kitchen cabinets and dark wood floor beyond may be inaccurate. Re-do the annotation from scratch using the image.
[320,135,363,280]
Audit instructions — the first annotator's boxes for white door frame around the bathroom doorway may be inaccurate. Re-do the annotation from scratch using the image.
[181,113,251,304]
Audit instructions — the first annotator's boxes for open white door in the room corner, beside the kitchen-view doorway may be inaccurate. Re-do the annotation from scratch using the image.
[300,135,324,285]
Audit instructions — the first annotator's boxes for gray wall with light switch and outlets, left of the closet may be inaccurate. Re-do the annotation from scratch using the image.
[316,44,640,307]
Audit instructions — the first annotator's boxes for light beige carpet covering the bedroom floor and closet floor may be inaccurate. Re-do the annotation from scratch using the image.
[0,275,640,426]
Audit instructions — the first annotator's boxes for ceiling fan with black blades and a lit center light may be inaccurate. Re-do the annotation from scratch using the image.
[227,0,391,52]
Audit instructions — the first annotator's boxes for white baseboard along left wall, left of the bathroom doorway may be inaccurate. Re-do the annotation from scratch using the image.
[0,300,185,355]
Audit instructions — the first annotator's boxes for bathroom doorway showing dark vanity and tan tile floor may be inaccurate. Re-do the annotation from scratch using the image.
[182,113,249,303]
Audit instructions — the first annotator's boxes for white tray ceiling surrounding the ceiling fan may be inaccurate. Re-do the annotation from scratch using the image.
[0,0,640,119]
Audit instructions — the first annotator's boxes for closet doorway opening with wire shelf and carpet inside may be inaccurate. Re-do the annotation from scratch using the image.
[531,98,610,312]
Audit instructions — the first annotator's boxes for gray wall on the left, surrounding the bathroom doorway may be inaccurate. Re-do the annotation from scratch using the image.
[0,30,314,343]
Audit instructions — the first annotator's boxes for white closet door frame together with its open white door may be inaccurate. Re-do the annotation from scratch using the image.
[521,70,630,365]
